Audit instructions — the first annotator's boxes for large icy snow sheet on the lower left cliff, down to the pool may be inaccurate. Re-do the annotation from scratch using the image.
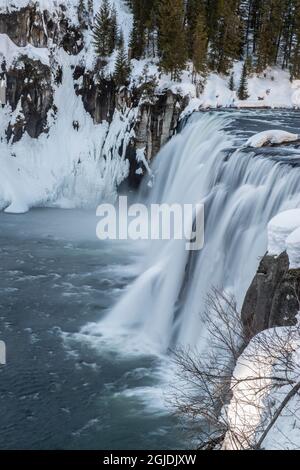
[0,50,134,213]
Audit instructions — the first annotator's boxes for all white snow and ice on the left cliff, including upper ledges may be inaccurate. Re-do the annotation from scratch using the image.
[0,0,137,213]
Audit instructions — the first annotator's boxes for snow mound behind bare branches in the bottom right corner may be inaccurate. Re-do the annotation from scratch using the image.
[223,325,300,450]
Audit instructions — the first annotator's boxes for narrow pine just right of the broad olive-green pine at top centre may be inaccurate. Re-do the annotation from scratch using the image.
[193,12,208,80]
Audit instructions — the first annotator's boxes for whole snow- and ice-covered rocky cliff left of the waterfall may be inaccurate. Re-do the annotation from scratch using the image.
[0,0,188,210]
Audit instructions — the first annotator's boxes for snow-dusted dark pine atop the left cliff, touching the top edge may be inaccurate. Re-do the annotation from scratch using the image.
[93,0,112,57]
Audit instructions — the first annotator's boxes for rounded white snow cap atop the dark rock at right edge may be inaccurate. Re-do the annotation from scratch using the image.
[268,209,300,256]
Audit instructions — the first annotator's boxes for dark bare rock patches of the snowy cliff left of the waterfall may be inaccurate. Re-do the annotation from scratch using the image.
[0,2,188,187]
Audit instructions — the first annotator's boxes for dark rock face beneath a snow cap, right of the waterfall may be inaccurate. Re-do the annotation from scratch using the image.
[242,253,300,339]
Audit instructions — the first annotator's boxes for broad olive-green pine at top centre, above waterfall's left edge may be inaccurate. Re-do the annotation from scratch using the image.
[159,0,187,80]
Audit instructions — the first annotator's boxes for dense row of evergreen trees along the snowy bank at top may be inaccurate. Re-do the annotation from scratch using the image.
[94,0,300,88]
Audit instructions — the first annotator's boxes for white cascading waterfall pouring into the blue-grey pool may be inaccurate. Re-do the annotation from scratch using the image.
[85,113,300,352]
